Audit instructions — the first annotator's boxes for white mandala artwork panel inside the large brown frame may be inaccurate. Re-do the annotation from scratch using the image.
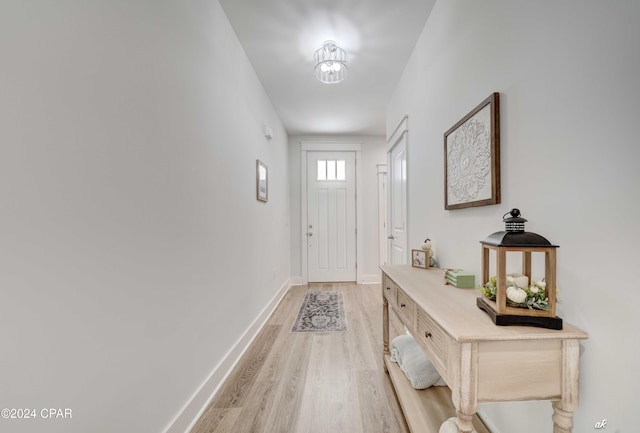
[447,105,491,204]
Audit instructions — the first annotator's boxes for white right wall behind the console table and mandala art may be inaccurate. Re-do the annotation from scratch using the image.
[388,0,640,433]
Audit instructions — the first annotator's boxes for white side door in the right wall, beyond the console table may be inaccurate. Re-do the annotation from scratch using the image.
[388,132,409,265]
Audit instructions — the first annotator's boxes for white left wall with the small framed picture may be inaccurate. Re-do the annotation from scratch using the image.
[0,0,290,433]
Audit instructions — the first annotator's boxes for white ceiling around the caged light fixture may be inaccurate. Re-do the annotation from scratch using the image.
[220,0,435,135]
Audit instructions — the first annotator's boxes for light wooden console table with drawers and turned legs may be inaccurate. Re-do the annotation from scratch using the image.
[380,265,587,433]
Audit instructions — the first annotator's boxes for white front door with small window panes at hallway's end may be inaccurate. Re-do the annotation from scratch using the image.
[307,152,356,282]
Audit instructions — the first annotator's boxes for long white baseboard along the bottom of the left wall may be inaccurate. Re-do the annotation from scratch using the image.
[164,280,292,433]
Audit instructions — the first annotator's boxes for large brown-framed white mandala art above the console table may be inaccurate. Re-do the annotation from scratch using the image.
[444,93,500,210]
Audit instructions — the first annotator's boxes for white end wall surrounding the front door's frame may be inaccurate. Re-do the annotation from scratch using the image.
[289,135,386,283]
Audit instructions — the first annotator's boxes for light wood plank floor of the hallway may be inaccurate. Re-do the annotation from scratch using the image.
[191,283,409,433]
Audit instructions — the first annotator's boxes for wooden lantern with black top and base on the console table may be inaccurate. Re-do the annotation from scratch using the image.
[477,209,562,329]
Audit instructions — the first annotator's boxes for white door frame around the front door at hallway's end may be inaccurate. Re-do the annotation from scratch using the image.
[300,141,364,284]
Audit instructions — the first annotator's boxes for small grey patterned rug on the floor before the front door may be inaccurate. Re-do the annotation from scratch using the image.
[291,291,347,332]
